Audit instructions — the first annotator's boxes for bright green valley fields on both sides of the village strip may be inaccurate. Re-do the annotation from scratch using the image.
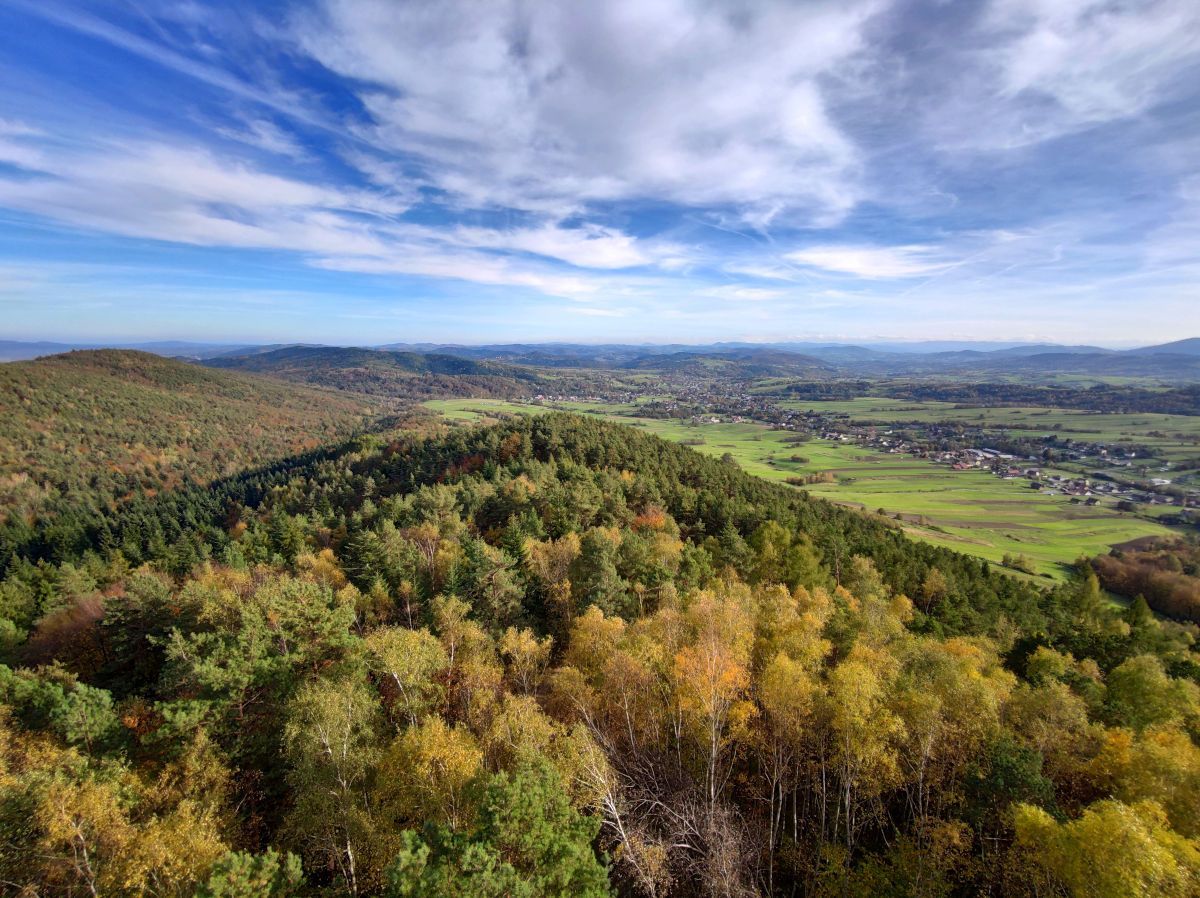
[425,400,1200,579]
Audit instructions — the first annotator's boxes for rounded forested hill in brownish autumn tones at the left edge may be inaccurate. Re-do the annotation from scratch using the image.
[0,349,378,530]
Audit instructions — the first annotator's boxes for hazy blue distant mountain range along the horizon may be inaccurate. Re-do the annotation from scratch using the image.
[9,337,1200,387]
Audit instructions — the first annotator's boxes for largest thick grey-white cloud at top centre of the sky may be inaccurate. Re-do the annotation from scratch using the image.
[295,0,880,221]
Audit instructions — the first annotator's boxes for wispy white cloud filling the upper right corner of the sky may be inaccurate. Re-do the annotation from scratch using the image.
[892,0,1200,154]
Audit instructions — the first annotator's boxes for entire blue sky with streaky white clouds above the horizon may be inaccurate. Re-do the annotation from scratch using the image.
[0,0,1200,346]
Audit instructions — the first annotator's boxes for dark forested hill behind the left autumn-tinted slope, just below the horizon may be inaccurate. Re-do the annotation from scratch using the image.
[203,346,540,397]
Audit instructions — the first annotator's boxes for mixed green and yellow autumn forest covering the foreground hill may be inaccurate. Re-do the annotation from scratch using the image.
[0,414,1200,898]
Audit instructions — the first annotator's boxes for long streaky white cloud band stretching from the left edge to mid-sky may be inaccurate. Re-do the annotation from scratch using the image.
[0,130,683,298]
